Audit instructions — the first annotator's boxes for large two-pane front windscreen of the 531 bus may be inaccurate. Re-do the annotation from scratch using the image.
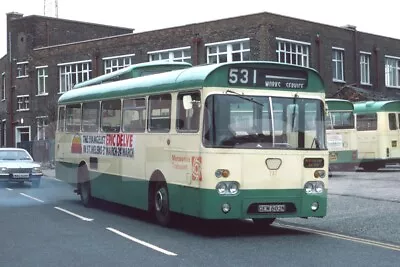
[203,95,325,149]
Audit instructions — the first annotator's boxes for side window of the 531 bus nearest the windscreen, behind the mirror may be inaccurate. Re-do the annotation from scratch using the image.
[176,92,201,132]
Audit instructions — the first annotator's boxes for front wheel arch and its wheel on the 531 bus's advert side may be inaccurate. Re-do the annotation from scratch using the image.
[148,170,172,226]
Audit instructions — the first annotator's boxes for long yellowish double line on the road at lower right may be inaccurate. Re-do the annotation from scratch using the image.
[274,223,400,251]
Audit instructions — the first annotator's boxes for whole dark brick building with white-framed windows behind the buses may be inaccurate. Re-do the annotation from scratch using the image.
[0,12,400,146]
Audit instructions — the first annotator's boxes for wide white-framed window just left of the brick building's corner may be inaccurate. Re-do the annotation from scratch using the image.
[205,38,250,64]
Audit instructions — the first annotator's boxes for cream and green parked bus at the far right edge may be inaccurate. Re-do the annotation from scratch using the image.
[354,100,400,171]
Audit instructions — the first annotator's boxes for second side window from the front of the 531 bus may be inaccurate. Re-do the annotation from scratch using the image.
[148,94,171,133]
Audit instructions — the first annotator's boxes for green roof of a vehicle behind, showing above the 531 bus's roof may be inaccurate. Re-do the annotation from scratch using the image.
[74,61,192,89]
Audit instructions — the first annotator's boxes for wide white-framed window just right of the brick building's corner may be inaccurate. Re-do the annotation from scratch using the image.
[276,38,311,67]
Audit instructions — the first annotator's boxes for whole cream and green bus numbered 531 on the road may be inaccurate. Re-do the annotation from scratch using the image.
[56,61,328,225]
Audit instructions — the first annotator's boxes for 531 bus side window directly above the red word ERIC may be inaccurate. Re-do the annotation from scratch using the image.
[101,99,121,133]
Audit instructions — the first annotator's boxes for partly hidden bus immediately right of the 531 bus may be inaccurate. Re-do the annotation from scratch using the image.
[326,99,359,171]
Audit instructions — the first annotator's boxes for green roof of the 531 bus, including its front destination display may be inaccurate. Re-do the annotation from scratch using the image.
[58,61,325,104]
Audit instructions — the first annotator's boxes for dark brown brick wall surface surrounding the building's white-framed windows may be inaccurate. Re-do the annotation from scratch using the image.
[0,13,400,148]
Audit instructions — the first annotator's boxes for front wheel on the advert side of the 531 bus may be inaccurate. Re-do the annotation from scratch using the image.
[152,183,172,226]
